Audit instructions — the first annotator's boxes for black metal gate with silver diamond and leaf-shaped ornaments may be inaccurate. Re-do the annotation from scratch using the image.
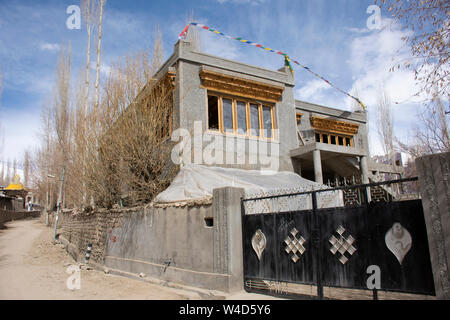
[242,178,435,299]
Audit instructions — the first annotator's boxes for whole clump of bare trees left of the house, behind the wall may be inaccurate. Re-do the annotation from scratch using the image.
[35,25,178,209]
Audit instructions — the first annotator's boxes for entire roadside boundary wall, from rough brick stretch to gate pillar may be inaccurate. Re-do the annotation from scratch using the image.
[47,188,244,292]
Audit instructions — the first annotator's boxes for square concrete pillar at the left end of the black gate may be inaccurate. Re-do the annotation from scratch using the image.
[213,187,244,292]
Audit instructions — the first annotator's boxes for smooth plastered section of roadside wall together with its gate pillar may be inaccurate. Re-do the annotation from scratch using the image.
[104,188,243,292]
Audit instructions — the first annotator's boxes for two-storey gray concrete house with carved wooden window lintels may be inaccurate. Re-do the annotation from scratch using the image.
[150,33,369,183]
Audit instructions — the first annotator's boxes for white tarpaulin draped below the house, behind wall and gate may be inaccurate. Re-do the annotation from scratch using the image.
[154,164,342,213]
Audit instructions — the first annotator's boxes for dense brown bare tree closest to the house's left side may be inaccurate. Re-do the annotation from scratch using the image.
[89,48,177,207]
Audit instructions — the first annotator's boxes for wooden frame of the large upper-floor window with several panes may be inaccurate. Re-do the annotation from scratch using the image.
[206,92,277,140]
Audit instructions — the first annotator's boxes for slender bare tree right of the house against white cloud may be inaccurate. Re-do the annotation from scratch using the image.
[377,84,395,164]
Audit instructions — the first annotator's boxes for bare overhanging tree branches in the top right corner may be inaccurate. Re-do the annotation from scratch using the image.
[377,0,450,100]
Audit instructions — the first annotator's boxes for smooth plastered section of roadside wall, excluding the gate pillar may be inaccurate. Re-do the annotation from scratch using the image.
[105,205,227,289]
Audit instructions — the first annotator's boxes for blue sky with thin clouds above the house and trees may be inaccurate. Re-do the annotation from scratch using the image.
[0,0,432,170]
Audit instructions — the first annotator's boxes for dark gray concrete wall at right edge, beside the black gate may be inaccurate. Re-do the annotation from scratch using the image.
[416,152,450,300]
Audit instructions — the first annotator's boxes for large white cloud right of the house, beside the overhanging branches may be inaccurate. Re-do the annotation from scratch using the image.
[346,19,425,154]
